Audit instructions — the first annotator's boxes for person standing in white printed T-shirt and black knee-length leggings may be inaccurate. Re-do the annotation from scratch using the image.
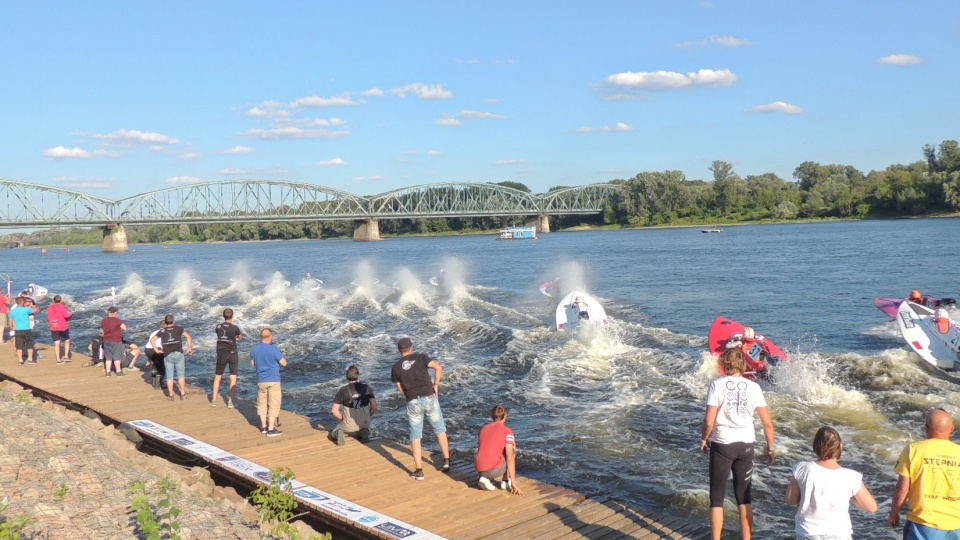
[700,348,774,540]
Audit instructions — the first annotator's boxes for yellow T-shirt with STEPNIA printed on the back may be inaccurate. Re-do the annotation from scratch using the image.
[895,439,960,531]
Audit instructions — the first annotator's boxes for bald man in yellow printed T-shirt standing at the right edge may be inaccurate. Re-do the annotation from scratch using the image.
[889,408,960,540]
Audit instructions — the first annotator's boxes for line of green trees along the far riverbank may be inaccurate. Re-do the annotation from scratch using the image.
[20,140,960,245]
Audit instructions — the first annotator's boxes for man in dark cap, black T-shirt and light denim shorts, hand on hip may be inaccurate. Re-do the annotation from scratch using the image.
[390,338,450,480]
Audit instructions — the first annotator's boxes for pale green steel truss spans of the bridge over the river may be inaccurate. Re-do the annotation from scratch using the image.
[0,180,621,228]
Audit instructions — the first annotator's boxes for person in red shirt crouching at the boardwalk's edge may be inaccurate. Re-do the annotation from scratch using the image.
[473,405,523,495]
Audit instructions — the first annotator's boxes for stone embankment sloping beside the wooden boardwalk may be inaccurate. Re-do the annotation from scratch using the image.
[0,381,316,540]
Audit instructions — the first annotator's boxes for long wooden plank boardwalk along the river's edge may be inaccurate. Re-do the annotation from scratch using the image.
[0,345,709,540]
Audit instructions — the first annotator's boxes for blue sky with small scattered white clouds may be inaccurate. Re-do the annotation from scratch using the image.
[0,0,960,199]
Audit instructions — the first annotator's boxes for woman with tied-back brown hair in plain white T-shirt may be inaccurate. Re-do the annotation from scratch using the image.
[787,426,877,540]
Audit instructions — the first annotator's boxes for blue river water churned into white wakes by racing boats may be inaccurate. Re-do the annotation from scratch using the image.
[2,219,960,538]
